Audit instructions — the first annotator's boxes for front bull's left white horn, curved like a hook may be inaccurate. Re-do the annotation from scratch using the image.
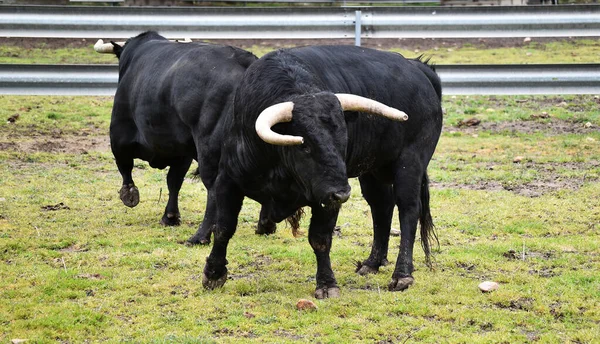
[254,102,304,146]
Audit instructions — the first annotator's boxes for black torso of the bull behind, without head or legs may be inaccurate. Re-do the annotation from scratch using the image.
[111,41,253,156]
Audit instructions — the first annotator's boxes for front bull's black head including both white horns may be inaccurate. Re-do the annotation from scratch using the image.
[255,92,408,207]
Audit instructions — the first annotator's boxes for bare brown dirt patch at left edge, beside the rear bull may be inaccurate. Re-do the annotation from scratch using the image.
[0,135,110,154]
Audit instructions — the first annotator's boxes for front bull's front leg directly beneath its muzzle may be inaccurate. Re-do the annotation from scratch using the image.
[308,205,340,299]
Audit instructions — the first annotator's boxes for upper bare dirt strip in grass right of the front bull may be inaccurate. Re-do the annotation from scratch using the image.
[444,118,599,135]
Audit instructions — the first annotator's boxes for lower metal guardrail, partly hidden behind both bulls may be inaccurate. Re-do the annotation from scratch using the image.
[0,64,600,96]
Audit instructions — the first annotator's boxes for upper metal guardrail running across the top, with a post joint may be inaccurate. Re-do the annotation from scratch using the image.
[0,5,600,39]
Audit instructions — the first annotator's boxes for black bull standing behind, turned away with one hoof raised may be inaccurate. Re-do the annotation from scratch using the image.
[110,31,284,239]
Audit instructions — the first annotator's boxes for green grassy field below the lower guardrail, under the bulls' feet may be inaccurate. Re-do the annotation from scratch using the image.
[0,96,600,343]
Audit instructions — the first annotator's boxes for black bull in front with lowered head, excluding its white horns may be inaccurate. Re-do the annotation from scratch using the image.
[203,46,442,298]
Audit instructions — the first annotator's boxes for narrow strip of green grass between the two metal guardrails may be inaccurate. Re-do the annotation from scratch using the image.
[0,38,600,64]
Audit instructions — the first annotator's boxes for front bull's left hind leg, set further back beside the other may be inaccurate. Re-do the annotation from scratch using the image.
[356,174,394,275]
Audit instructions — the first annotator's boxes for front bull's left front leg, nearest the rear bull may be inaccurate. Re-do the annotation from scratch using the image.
[202,173,244,289]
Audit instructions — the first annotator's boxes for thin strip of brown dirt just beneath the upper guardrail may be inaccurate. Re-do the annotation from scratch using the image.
[0,37,592,50]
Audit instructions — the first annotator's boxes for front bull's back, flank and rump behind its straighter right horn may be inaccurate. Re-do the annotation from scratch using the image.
[290,46,442,176]
